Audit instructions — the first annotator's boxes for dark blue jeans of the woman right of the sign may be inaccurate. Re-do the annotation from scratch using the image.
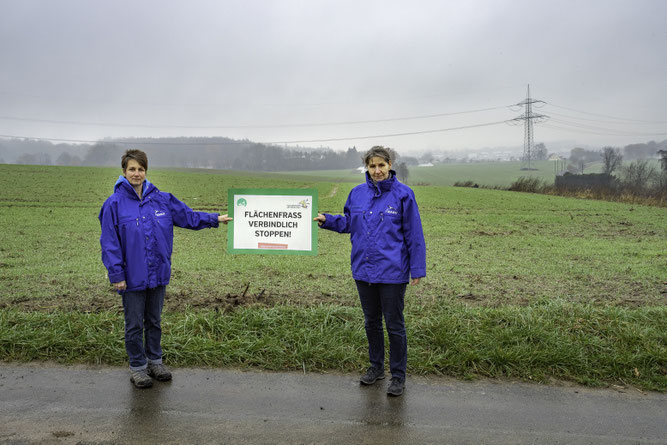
[356,281,408,380]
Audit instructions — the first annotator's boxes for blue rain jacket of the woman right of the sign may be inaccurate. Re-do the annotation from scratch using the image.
[322,170,426,284]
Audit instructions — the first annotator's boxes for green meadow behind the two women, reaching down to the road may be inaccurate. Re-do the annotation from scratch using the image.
[0,163,667,391]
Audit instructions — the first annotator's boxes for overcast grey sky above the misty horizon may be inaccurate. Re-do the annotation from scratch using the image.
[0,0,667,153]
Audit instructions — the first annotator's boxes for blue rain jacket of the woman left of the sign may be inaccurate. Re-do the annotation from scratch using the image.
[99,175,218,291]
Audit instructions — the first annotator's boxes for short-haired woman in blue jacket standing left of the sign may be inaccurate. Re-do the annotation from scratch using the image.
[99,150,231,388]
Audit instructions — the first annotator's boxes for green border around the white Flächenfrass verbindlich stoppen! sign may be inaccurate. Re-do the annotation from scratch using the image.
[227,189,319,255]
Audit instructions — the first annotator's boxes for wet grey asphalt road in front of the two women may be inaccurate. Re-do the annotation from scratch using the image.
[0,363,667,445]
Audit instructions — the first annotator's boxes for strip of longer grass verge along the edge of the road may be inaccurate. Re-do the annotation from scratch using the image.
[0,300,667,391]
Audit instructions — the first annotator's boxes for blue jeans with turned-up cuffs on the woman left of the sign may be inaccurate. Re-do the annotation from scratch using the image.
[123,286,165,371]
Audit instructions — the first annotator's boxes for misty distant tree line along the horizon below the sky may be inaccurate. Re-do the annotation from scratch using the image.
[0,137,667,176]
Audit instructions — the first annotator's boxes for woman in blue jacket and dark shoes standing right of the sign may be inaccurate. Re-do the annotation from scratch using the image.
[315,146,426,396]
